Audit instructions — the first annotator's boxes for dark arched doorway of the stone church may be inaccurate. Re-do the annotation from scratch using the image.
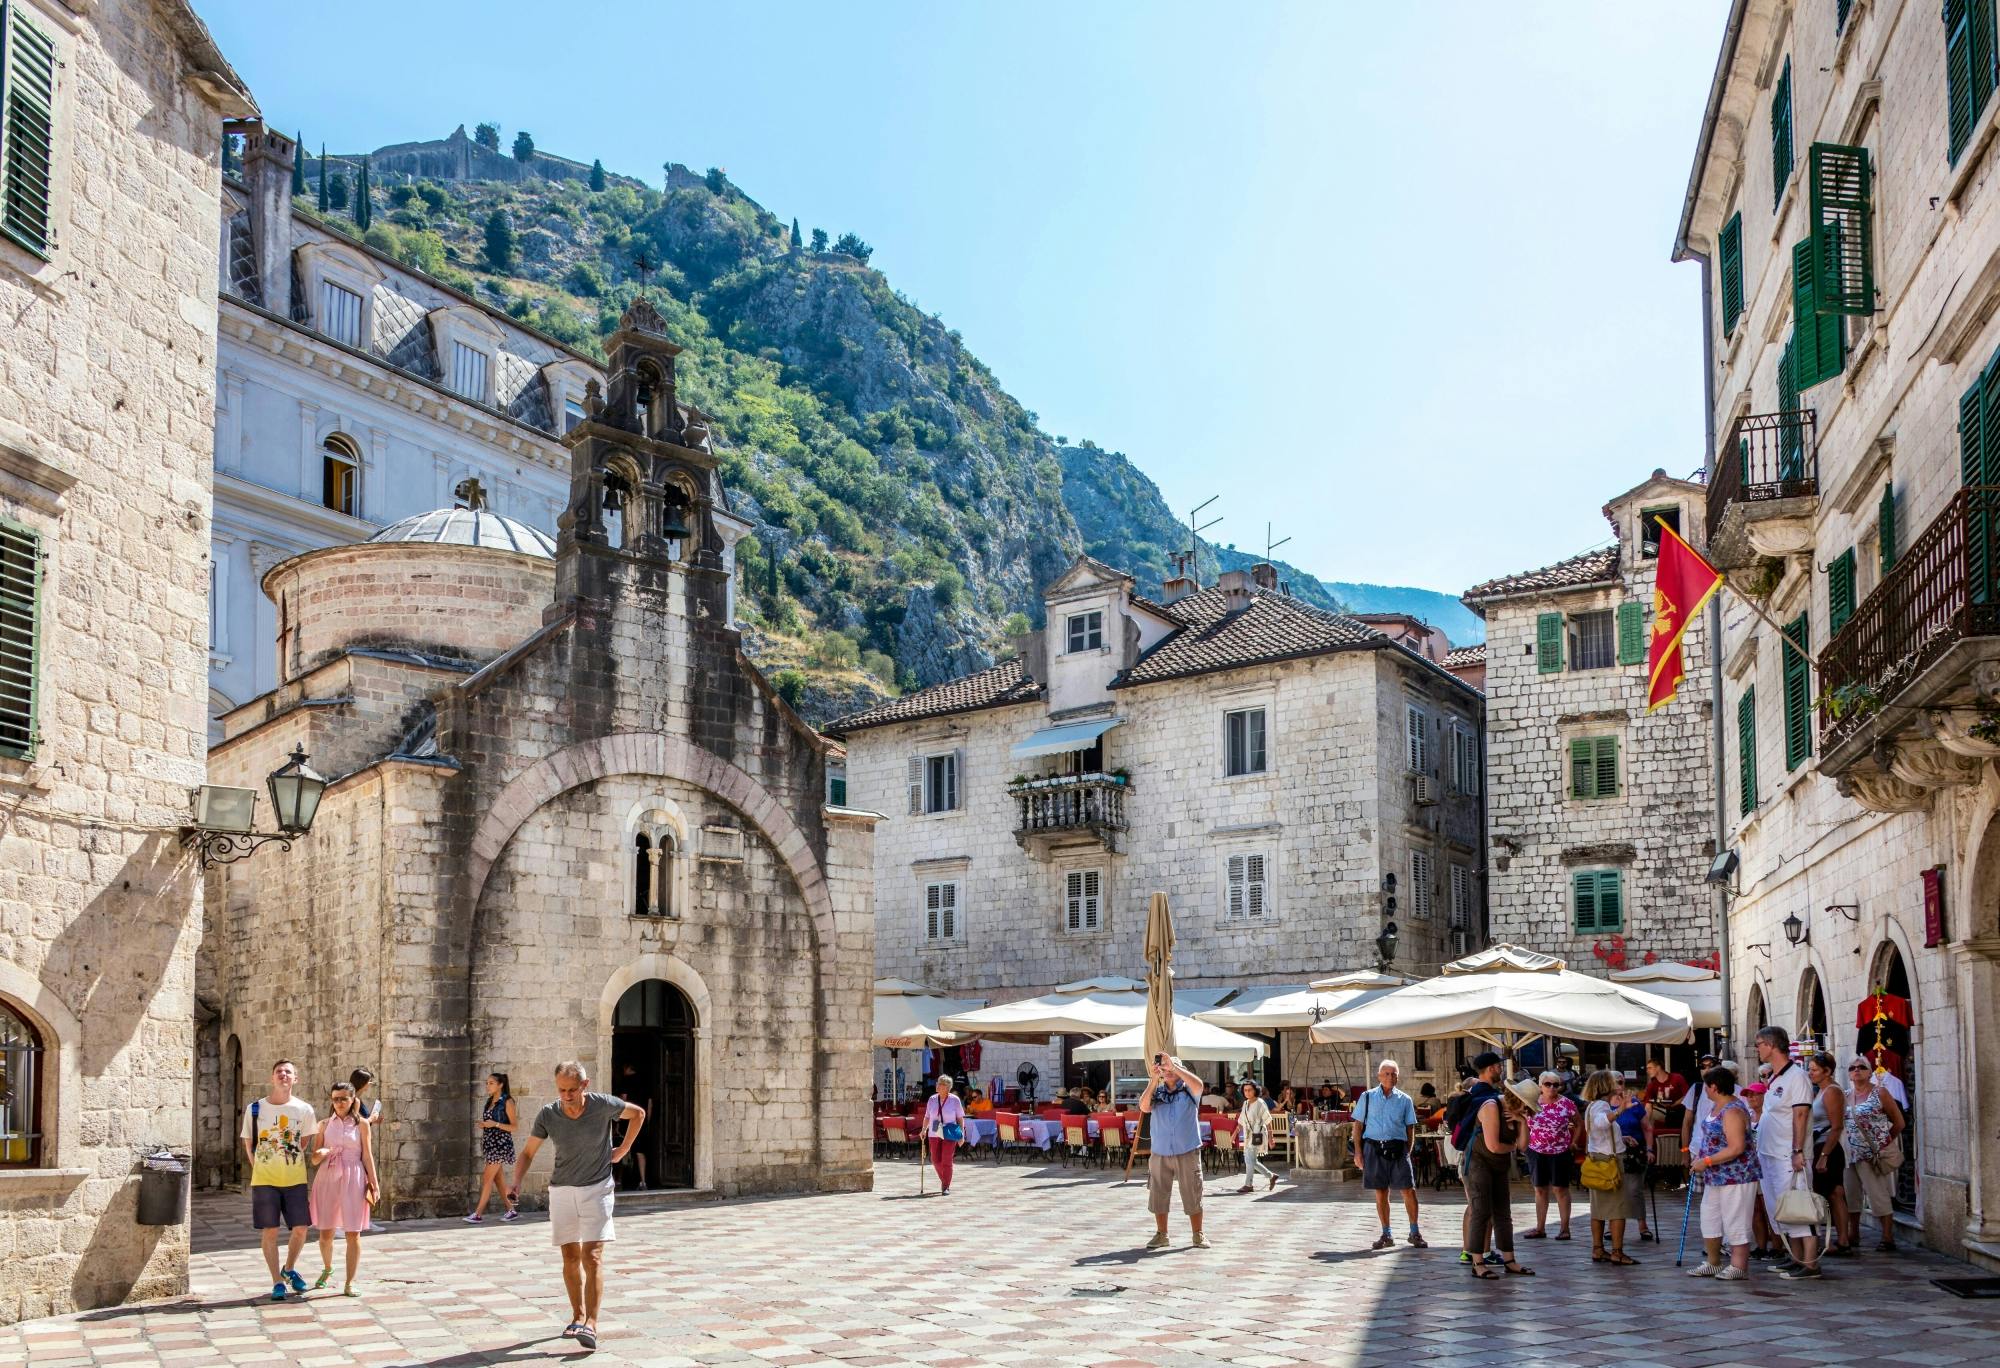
[606,978,698,1188]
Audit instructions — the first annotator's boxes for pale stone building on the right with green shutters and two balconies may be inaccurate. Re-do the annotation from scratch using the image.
[1676,0,2000,1266]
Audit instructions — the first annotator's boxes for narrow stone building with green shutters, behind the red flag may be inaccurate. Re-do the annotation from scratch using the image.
[1464,474,1718,974]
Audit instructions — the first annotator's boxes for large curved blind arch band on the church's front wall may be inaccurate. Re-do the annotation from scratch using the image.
[464,732,836,952]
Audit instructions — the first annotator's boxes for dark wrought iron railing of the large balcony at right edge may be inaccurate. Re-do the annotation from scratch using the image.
[1820,484,2000,750]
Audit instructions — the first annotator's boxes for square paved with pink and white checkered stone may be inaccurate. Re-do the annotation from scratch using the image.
[0,1160,2000,1368]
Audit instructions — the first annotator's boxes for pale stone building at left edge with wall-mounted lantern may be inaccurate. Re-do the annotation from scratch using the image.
[0,0,254,1320]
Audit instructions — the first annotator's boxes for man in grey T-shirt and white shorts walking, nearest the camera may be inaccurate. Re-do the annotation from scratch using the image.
[510,1060,646,1350]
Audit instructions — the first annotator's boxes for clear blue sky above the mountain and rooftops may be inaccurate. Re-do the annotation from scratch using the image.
[196,0,1726,592]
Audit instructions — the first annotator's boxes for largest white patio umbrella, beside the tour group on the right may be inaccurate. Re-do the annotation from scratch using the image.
[1312,946,1694,1058]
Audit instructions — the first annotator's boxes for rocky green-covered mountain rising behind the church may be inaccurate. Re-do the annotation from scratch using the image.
[298,130,1488,716]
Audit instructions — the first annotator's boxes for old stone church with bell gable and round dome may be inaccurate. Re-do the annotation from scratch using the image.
[196,300,874,1216]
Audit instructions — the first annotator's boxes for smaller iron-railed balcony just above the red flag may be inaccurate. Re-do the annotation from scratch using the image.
[1708,408,1820,570]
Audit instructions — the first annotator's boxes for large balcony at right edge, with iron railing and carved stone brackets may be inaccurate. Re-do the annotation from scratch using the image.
[1820,486,2000,784]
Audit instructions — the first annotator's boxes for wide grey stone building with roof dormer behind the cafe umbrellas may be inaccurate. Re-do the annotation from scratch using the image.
[828,558,1484,1090]
